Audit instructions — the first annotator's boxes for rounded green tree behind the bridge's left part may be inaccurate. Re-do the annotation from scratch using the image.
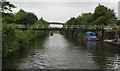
[15,9,38,25]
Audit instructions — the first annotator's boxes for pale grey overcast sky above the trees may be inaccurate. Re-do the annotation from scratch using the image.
[8,0,119,23]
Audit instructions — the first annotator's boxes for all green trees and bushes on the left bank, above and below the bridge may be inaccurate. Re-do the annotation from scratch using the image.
[0,0,48,57]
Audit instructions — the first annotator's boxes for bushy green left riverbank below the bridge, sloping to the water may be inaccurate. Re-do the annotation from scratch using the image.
[2,23,48,57]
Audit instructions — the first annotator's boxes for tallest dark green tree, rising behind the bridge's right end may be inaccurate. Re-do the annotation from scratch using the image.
[93,4,117,25]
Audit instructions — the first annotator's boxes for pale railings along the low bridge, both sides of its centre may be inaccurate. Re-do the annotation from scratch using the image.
[12,24,113,29]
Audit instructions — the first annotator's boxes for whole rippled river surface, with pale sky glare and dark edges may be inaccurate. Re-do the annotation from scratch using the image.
[3,33,120,69]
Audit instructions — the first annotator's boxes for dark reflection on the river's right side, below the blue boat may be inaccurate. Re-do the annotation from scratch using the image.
[62,33,120,69]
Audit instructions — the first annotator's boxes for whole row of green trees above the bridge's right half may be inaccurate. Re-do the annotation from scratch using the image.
[66,4,120,25]
